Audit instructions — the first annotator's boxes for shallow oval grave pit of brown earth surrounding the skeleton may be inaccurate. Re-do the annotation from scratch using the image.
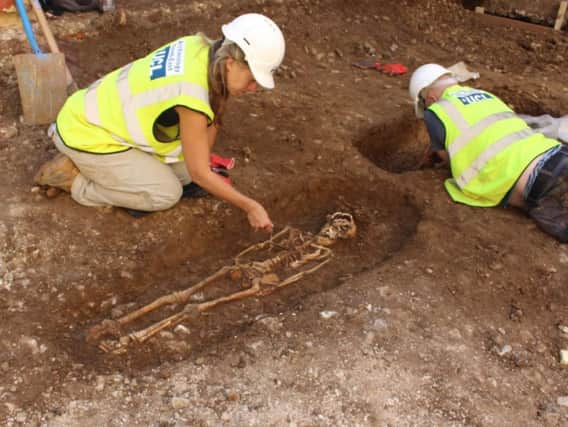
[55,178,420,370]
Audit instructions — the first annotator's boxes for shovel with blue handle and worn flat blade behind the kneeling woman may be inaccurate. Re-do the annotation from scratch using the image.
[14,0,67,125]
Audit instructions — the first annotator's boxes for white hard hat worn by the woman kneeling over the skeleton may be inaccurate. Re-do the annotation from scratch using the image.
[221,13,286,89]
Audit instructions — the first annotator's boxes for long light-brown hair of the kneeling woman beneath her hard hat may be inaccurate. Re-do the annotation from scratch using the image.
[197,33,246,125]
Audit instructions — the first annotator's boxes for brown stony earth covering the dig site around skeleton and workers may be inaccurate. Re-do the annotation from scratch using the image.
[0,0,568,426]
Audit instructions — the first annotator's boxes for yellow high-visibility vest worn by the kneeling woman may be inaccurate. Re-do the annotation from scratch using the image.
[57,36,215,163]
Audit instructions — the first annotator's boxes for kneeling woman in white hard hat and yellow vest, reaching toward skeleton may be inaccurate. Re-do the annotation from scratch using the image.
[35,14,285,231]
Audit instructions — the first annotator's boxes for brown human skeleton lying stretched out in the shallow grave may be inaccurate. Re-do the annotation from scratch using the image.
[88,212,357,354]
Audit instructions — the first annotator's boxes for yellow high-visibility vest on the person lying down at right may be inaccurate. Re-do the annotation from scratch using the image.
[428,85,559,207]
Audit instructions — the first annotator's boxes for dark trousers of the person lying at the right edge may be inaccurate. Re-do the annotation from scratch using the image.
[526,145,568,243]
